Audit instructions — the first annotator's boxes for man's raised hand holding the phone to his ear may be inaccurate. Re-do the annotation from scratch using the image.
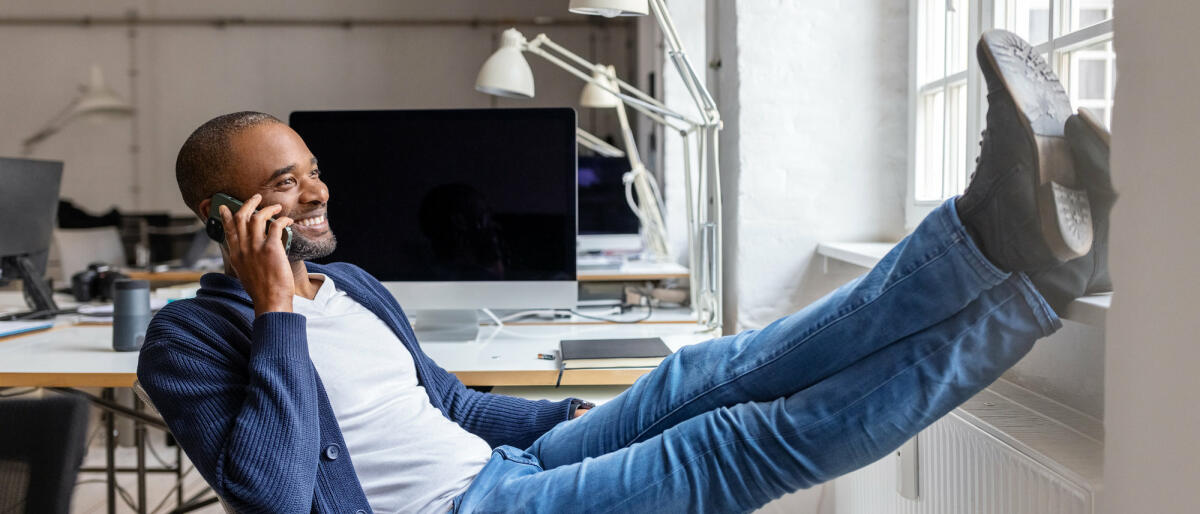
[221,195,295,317]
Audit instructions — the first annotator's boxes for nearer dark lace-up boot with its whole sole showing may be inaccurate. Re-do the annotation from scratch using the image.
[955,30,1092,271]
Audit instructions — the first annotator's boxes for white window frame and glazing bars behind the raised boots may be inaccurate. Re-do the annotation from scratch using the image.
[905,0,1116,231]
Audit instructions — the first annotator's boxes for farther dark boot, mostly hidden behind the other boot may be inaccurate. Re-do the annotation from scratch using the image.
[1030,109,1117,315]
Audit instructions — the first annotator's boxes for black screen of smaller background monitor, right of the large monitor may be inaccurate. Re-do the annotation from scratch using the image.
[580,156,641,234]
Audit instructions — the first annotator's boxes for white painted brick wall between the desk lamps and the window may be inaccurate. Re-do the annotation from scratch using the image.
[721,0,908,329]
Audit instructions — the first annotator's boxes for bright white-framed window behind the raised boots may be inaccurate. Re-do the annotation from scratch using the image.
[907,0,1116,227]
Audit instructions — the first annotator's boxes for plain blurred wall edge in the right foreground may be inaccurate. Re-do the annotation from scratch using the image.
[1102,0,1200,514]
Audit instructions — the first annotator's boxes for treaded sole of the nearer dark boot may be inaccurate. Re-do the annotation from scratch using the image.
[980,31,1092,262]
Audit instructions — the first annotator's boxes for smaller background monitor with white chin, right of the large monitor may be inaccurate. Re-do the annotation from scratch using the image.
[578,155,642,252]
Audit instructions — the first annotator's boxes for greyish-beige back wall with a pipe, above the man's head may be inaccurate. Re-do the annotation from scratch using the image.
[0,0,635,213]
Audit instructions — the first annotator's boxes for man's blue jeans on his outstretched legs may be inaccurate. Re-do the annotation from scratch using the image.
[455,199,1061,514]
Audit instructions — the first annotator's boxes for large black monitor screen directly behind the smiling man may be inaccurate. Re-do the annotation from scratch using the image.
[290,108,576,281]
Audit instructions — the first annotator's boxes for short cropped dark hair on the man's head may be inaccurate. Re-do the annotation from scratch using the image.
[175,110,283,216]
